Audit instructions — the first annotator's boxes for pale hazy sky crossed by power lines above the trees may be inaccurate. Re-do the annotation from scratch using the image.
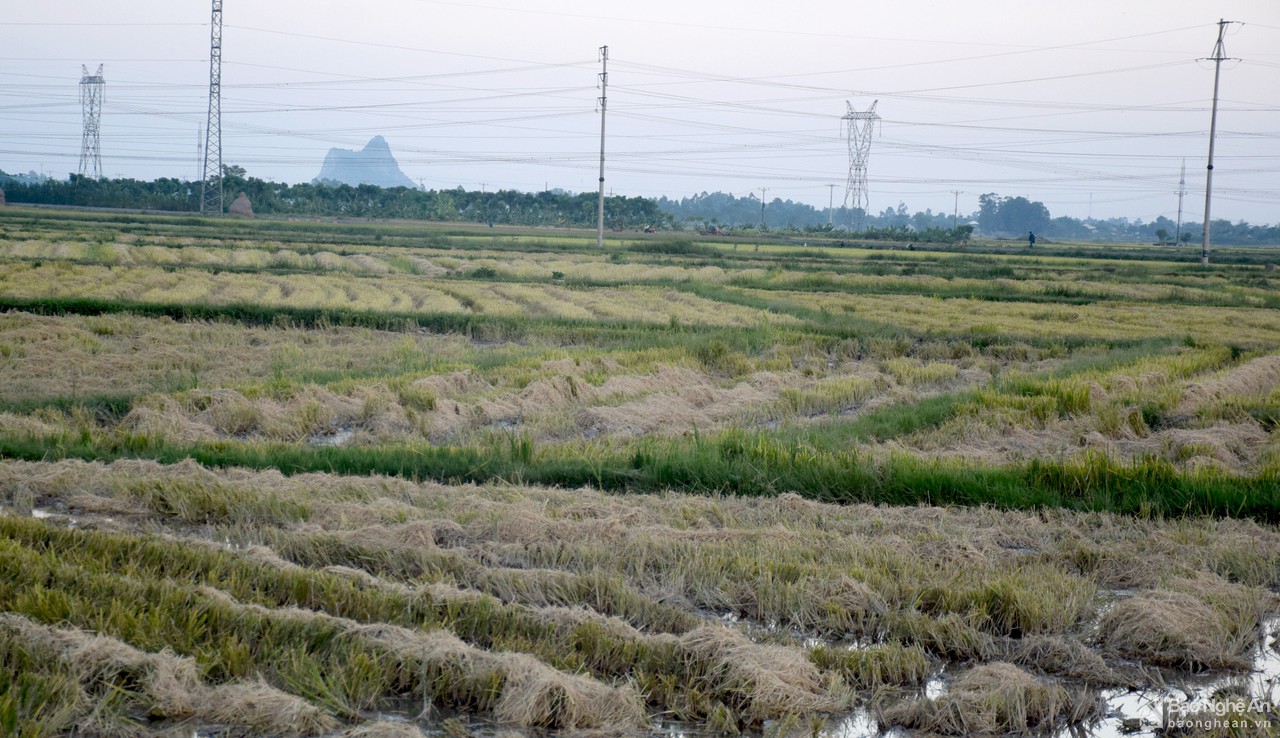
[0,0,1280,224]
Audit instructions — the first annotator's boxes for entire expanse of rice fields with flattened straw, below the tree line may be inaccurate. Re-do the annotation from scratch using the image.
[0,207,1280,738]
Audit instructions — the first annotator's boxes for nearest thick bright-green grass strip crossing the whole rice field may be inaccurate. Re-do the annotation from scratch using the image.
[0,431,1280,522]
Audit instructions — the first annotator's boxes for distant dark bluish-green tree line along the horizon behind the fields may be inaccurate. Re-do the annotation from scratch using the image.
[0,166,1280,246]
